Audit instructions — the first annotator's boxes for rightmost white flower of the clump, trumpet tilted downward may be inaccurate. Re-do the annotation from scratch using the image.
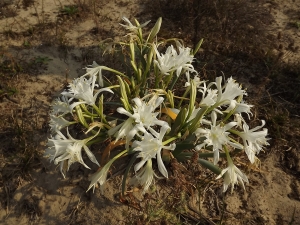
[237,120,269,163]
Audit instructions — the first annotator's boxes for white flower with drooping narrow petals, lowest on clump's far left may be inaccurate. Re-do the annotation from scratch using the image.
[45,129,99,177]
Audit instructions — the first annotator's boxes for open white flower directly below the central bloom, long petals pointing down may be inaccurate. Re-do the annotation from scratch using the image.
[132,126,176,178]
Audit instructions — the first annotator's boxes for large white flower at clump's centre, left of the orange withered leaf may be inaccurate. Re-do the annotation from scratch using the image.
[108,95,169,148]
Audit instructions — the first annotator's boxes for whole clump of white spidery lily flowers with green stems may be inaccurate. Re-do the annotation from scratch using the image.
[46,18,268,196]
